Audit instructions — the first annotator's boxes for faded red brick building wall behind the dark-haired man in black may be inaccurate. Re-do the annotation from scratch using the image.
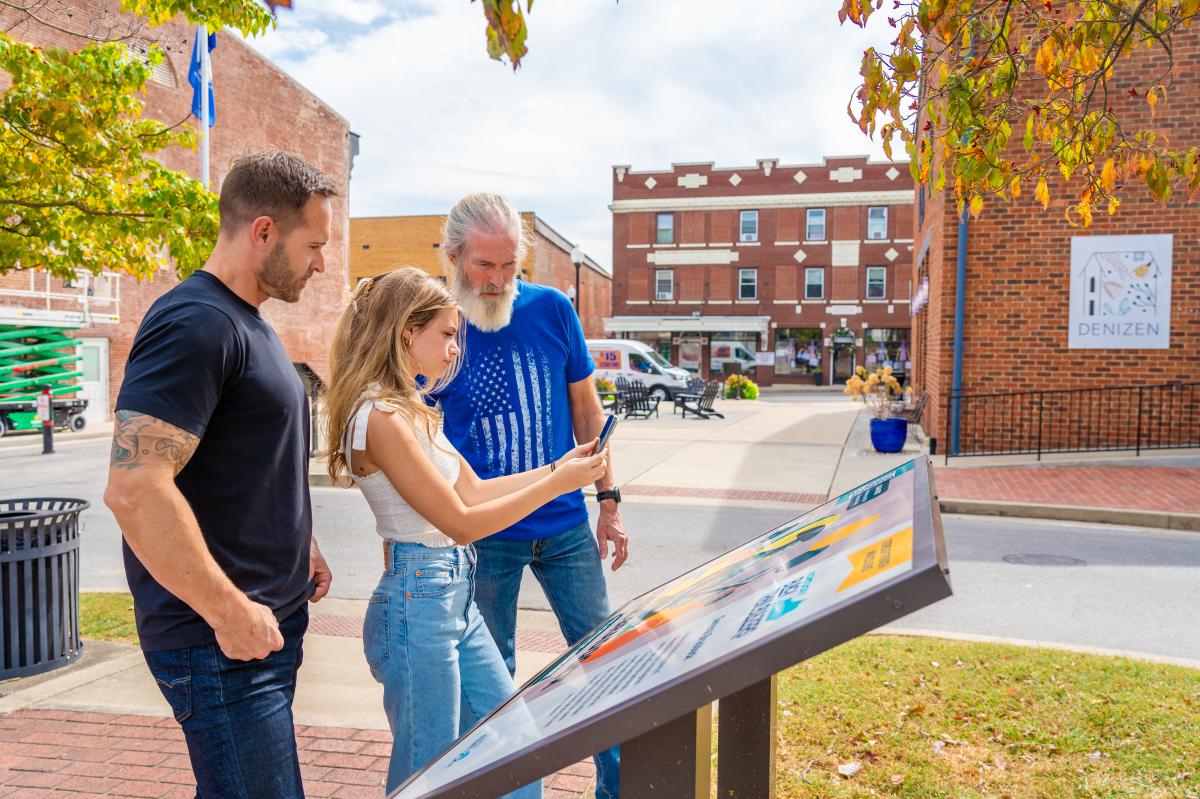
[0,0,349,410]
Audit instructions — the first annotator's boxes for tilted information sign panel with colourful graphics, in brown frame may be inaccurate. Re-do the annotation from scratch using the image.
[392,459,950,799]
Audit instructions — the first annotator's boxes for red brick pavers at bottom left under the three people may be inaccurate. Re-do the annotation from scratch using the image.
[0,710,595,799]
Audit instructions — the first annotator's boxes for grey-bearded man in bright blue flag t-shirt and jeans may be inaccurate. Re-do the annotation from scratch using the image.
[438,189,628,799]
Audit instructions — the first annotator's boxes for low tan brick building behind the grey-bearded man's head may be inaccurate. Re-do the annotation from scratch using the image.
[350,211,612,338]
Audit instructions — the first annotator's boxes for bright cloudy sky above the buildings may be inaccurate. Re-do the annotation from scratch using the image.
[238,0,893,266]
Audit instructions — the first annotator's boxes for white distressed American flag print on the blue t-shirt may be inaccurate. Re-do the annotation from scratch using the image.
[468,344,554,475]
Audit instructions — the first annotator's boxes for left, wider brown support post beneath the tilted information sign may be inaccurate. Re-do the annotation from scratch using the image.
[620,704,713,799]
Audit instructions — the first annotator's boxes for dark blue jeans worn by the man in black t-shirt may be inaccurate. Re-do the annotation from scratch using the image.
[144,607,308,799]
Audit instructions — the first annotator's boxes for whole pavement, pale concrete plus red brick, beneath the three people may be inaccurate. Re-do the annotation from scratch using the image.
[0,599,595,799]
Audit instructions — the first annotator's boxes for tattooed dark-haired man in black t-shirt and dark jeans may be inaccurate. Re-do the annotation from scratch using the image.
[104,151,337,799]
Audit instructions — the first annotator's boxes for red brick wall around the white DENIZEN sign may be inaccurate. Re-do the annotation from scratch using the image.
[913,31,1200,445]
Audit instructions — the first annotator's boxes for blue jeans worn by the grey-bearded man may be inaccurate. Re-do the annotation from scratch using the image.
[475,522,620,799]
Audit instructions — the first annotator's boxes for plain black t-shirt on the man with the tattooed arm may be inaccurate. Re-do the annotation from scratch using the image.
[116,271,312,651]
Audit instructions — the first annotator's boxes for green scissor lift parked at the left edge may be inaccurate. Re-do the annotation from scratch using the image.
[0,325,88,435]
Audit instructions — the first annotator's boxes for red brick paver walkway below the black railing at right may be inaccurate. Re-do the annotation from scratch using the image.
[934,465,1200,513]
